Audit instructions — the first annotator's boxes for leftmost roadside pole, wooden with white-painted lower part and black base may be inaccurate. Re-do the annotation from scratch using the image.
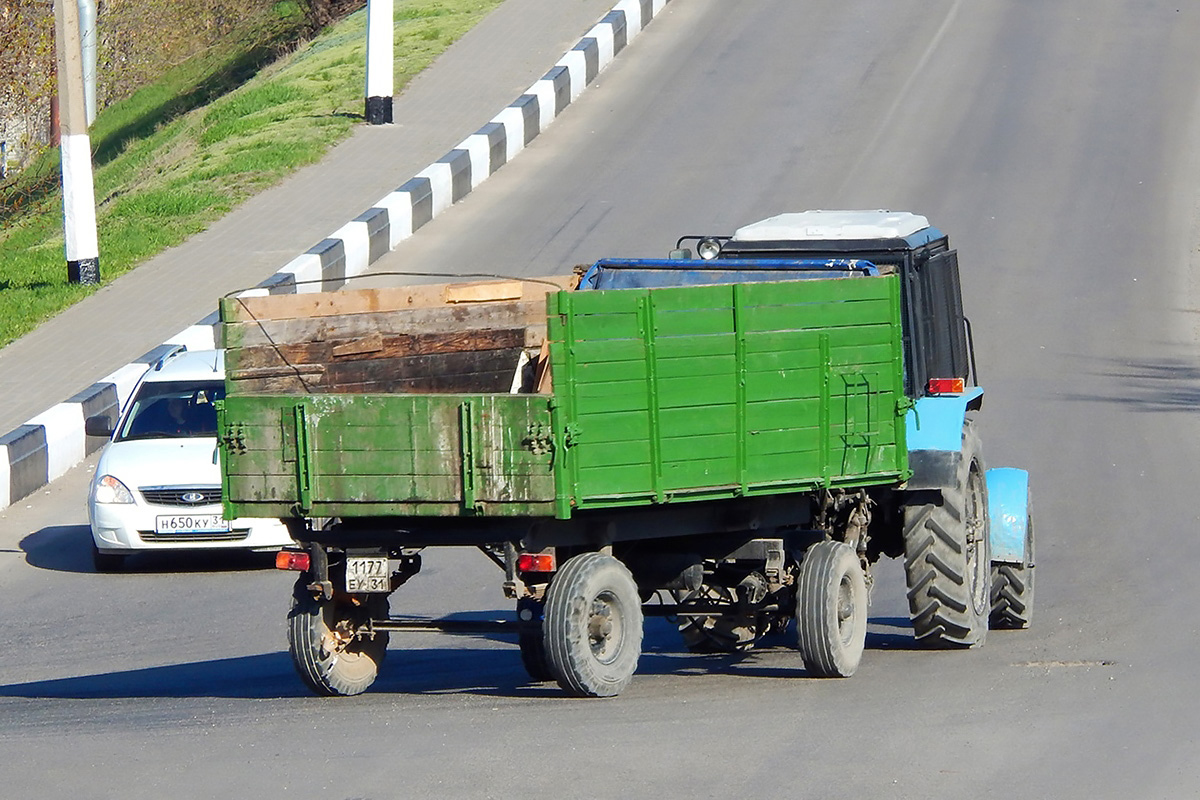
[54,0,100,283]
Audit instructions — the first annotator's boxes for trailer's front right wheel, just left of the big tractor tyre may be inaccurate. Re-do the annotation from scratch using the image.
[796,541,866,678]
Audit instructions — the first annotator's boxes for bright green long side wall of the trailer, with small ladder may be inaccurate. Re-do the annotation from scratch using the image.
[548,276,907,516]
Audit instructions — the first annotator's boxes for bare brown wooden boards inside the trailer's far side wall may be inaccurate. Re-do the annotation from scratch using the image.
[221,277,575,396]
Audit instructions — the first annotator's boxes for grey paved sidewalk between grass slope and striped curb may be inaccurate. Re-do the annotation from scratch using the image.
[0,0,614,434]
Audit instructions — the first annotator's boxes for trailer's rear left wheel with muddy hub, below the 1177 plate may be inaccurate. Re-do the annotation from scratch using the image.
[288,575,388,697]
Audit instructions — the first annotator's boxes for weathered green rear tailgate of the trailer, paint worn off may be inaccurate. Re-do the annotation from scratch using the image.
[218,395,556,517]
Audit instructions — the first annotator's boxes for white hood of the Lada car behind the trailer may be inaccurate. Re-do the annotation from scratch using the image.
[96,437,221,489]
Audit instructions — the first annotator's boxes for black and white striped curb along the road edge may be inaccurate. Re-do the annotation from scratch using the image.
[0,0,668,509]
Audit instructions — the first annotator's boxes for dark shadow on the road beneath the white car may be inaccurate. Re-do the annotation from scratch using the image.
[19,525,275,575]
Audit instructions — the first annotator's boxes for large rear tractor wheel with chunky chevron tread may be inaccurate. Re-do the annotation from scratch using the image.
[904,420,991,648]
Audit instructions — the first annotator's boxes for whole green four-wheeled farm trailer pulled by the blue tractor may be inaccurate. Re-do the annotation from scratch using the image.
[218,209,1024,696]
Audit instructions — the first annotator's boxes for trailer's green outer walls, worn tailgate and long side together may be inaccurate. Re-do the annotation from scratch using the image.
[220,276,907,518]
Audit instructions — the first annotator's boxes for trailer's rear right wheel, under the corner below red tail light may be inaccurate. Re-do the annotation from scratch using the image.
[545,553,642,697]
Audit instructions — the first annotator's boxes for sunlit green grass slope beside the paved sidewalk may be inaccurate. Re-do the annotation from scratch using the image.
[0,0,502,347]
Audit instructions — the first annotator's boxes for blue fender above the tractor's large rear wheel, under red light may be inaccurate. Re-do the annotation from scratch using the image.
[905,386,983,489]
